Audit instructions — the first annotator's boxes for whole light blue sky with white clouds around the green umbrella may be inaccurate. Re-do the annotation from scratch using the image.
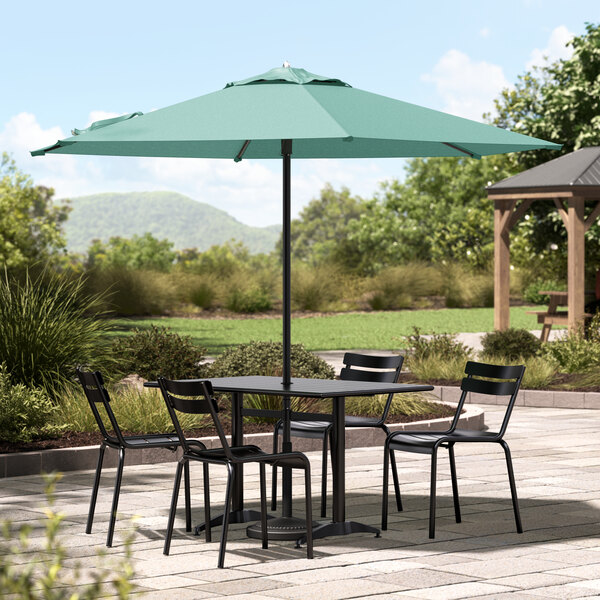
[0,0,600,225]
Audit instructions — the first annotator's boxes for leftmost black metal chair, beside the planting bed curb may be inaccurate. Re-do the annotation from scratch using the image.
[77,368,206,547]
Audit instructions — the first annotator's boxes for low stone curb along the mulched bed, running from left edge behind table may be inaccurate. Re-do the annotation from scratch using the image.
[0,406,485,478]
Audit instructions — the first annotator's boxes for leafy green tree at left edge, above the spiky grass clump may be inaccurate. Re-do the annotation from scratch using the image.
[0,153,71,268]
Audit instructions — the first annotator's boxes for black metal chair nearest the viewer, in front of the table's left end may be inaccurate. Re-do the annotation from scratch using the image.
[158,377,313,569]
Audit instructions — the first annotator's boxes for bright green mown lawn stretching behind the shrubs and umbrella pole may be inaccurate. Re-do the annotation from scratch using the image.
[109,306,542,354]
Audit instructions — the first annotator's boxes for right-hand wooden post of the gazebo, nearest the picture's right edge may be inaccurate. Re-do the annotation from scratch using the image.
[567,197,585,332]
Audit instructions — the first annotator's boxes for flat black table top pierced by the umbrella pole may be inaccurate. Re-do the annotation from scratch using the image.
[144,375,433,398]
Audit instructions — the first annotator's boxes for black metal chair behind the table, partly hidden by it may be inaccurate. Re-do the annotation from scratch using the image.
[271,352,404,517]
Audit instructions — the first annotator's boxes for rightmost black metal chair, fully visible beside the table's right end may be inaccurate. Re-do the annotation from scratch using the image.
[381,361,525,539]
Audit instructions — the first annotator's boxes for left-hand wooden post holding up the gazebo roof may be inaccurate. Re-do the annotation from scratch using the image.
[494,200,516,331]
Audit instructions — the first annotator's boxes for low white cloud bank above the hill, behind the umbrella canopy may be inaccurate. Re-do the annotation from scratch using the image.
[0,111,402,226]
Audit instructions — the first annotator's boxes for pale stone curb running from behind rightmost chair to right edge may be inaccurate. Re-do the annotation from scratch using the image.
[430,386,600,410]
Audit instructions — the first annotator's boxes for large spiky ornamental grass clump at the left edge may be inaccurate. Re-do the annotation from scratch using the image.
[0,271,110,395]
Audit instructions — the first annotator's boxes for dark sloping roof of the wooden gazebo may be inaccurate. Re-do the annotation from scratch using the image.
[487,146,600,196]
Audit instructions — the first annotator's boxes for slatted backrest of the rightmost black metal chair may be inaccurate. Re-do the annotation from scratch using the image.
[450,361,525,439]
